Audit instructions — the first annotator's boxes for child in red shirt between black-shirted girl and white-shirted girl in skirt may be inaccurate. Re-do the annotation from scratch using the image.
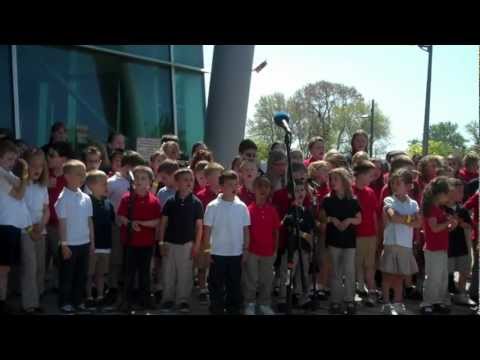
[352,161,378,307]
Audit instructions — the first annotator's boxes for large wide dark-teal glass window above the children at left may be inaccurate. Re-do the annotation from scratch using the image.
[17,46,173,149]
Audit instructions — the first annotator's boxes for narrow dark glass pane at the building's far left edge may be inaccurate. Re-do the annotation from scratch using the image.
[0,45,14,135]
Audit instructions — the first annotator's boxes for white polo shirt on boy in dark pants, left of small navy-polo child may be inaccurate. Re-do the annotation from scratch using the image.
[55,187,93,246]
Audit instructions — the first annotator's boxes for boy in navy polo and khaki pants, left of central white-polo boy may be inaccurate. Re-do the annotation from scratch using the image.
[160,168,203,313]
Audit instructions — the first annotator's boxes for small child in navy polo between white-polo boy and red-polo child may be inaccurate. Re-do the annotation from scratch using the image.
[85,170,115,308]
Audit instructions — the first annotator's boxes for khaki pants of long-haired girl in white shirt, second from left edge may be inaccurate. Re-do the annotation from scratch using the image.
[20,234,45,310]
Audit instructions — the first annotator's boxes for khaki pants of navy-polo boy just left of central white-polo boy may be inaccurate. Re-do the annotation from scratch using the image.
[162,241,193,305]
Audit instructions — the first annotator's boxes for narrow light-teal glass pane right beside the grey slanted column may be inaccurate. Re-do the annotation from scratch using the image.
[175,70,205,154]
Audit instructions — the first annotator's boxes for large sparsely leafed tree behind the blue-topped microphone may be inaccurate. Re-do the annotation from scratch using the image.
[248,81,390,154]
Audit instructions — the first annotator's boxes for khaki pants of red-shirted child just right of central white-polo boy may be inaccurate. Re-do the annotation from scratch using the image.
[242,252,275,305]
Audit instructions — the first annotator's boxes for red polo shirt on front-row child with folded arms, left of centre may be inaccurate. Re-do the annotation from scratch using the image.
[118,192,162,247]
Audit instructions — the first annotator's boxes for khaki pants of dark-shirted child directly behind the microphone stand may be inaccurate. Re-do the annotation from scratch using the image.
[278,250,311,305]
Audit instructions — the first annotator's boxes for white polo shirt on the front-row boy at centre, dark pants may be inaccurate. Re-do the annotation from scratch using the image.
[204,194,250,256]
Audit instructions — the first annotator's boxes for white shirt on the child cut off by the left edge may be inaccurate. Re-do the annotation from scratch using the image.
[0,166,32,229]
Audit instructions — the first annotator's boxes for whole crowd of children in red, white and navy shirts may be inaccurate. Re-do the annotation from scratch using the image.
[0,126,479,315]
